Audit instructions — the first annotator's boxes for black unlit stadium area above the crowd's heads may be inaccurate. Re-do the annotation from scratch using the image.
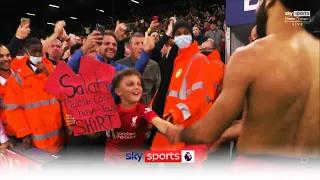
[0,0,225,44]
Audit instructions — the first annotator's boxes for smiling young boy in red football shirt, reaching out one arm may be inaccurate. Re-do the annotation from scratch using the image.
[67,69,173,165]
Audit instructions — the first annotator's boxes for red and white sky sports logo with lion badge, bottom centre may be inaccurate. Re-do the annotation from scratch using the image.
[126,150,195,163]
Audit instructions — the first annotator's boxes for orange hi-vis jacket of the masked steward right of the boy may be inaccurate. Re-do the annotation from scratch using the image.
[151,42,215,150]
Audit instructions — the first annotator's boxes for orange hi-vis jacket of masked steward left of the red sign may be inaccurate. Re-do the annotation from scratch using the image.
[4,57,64,153]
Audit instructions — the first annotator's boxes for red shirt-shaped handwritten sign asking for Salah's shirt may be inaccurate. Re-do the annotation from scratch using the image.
[45,57,121,136]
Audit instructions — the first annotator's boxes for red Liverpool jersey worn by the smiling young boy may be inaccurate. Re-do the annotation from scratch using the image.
[105,103,157,163]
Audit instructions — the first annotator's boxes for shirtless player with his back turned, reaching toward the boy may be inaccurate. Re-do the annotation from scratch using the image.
[167,0,320,161]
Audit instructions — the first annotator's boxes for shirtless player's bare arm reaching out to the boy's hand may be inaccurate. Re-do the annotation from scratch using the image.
[180,48,253,144]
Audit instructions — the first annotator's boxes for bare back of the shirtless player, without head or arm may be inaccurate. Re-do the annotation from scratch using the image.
[237,31,320,157]
